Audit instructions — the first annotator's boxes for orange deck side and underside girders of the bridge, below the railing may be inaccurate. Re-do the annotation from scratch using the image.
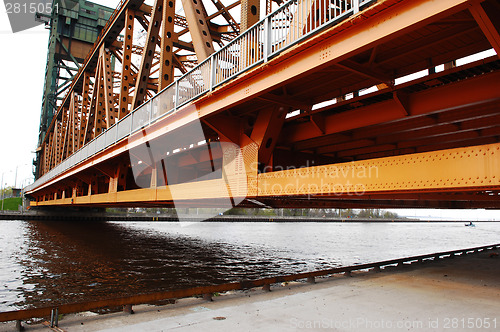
[28,0,500,208]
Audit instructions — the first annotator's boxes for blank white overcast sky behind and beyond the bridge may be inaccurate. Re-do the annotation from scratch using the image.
[0,0,500,220]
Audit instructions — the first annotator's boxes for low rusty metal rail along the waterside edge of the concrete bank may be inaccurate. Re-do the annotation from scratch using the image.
[0,244,500,322]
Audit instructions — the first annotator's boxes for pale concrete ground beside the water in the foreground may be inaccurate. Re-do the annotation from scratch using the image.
[0,252,500,331]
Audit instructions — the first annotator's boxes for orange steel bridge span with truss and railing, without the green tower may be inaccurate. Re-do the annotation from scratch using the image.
[26,0,500,208]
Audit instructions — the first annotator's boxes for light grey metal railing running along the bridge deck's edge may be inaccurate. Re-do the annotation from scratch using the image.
[26,0,376,192]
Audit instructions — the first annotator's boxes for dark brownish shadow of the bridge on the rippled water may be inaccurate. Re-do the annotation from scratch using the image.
[15,221,267,307]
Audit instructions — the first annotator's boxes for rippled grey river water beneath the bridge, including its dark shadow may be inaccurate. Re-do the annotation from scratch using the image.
[0,221,500,311]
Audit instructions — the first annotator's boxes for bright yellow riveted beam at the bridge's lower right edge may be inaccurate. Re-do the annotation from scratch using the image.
[258,144,500,197]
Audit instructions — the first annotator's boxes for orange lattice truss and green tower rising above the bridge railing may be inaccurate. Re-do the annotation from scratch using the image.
[35,0,258,178]
